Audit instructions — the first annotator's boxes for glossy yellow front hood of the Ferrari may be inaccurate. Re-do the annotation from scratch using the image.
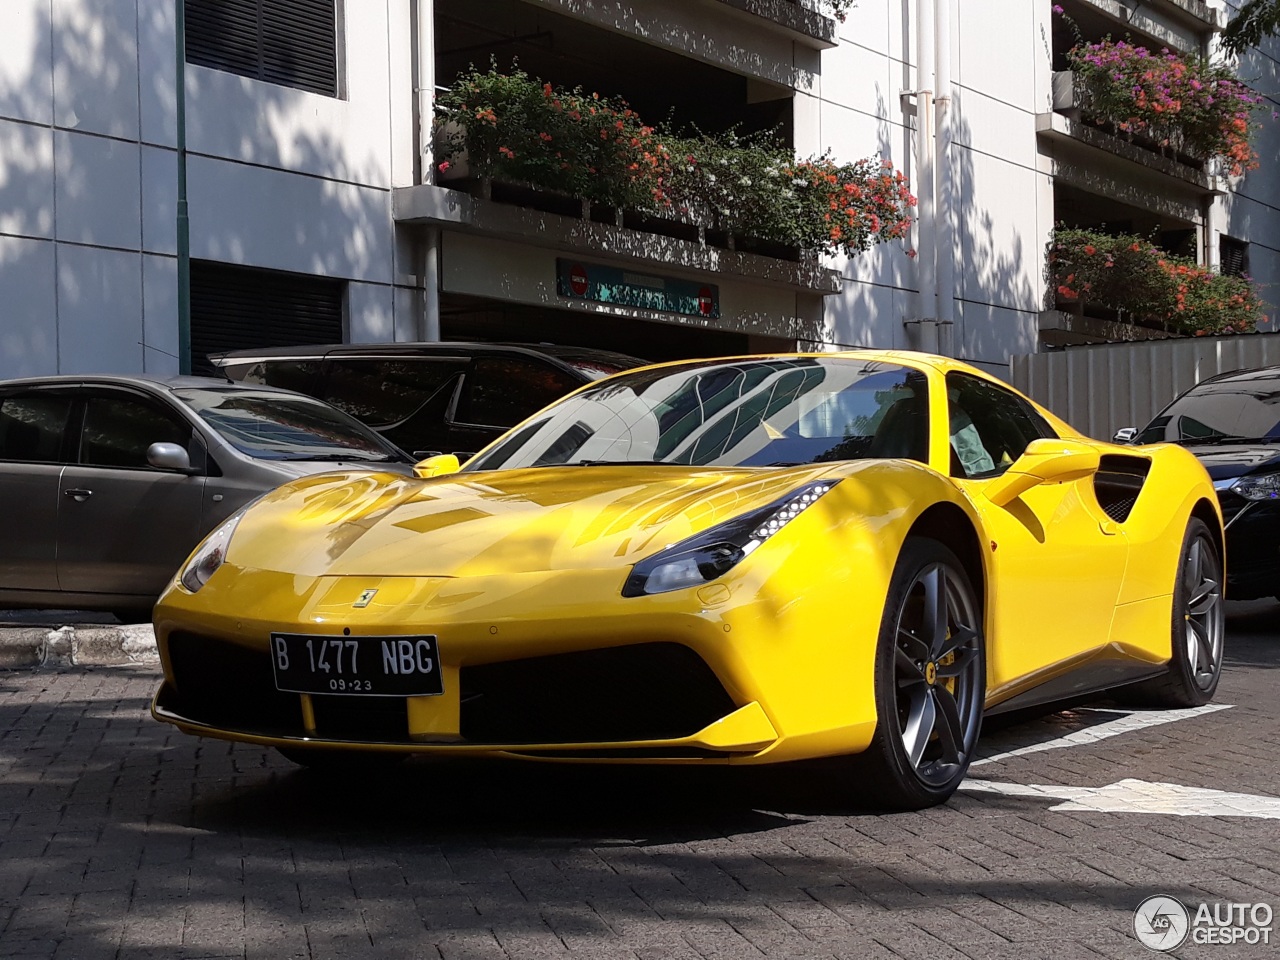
[228,463,861,576]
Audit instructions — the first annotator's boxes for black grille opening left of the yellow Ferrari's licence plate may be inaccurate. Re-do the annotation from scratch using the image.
[169,632,303,736]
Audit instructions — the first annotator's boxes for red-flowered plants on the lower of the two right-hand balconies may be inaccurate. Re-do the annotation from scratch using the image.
[1050,225,1266,337]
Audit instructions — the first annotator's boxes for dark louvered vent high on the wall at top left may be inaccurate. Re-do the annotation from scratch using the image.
[186,0,338,96]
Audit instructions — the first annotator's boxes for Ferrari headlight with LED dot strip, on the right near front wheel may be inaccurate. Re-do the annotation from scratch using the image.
[622,480,840,596]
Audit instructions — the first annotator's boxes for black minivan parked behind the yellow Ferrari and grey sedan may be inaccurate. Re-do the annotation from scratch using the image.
[209,342,646,458]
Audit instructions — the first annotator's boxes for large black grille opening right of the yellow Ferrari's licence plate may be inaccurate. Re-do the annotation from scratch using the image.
[461,643,735,744]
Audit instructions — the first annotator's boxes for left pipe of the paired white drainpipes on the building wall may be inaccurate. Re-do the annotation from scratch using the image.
[915,0,938,353]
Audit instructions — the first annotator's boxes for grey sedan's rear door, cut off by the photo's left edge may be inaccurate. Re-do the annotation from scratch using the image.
[0,388,74,595]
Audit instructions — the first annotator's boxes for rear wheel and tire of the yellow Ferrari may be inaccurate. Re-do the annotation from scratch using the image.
[1132,517,1226,707]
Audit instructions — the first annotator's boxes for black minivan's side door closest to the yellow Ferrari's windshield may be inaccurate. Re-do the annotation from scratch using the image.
[449,355,582,454]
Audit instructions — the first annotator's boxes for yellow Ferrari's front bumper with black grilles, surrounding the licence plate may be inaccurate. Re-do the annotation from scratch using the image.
[152,570,874,763]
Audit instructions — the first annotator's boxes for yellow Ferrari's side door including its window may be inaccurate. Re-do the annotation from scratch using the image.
[947,372,1129,695]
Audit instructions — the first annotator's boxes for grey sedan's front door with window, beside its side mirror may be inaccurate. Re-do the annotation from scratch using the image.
[58,387,205,596]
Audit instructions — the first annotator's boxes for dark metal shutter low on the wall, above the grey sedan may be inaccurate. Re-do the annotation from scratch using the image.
[191,260,346,374]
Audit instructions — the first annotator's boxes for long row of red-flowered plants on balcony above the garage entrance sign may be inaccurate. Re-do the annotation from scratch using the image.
[436,68,915,256]
